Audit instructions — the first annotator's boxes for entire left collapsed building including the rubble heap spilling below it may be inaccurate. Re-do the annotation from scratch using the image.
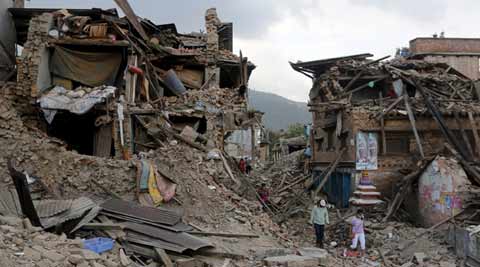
[0,1,280,266]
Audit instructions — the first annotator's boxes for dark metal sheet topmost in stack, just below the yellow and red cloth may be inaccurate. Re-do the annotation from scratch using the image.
[101,199,181,225]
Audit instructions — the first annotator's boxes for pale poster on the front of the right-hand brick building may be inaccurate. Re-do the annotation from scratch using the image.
[355,132,378,170]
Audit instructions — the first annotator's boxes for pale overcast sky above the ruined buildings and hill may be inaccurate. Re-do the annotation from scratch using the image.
[27,0,480,101]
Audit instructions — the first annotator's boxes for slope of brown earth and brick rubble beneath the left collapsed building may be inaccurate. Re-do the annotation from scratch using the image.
[0,89,287,262]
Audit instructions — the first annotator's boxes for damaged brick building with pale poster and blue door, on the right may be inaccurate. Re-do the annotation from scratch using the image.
[291,51,480,216]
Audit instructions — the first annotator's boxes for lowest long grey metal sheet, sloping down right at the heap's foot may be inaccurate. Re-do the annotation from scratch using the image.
[122,222,212,253]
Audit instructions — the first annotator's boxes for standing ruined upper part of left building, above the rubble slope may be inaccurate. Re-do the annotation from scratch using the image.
[6,1,261,162]
